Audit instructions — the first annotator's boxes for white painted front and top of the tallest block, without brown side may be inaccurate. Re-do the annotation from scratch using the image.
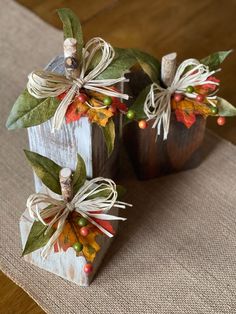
[28,56,93,192]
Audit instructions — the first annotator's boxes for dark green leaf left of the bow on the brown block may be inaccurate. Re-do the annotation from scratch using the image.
[124,84,151,125]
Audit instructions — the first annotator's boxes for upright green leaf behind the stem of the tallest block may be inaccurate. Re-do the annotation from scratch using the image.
[57,8,84,60]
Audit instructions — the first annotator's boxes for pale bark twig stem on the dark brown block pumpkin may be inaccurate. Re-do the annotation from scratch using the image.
[161,52,177,87]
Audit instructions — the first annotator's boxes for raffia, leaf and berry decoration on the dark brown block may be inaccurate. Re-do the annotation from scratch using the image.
[127,50,236,140]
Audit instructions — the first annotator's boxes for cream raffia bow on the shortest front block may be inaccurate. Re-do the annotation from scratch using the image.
[26,177,132,258]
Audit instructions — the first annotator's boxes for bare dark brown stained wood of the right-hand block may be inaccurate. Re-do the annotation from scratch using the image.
[124,112,206,180]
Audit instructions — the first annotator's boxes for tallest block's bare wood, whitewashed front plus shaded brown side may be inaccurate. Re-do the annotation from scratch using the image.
[28,56,123,192]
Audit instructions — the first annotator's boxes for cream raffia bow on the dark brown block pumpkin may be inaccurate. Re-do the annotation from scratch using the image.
[144,59,219,140]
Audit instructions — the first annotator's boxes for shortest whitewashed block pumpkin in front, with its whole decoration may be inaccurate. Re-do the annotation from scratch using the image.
[20,151,131,286]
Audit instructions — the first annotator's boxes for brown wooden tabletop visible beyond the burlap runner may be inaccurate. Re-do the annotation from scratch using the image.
[0,0,236,314]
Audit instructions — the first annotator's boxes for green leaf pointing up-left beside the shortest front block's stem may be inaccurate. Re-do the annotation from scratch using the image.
[24,150,61,195]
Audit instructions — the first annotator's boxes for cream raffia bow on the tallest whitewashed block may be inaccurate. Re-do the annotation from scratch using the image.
[27,37,129,132]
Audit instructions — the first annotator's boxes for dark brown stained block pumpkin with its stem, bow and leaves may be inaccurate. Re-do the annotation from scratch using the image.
[123,51,236,179]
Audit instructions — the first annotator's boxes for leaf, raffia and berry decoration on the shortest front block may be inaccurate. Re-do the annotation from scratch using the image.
[23,151,132,261]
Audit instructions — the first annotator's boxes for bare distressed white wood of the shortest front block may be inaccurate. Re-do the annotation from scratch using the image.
[20,186,119,286]
